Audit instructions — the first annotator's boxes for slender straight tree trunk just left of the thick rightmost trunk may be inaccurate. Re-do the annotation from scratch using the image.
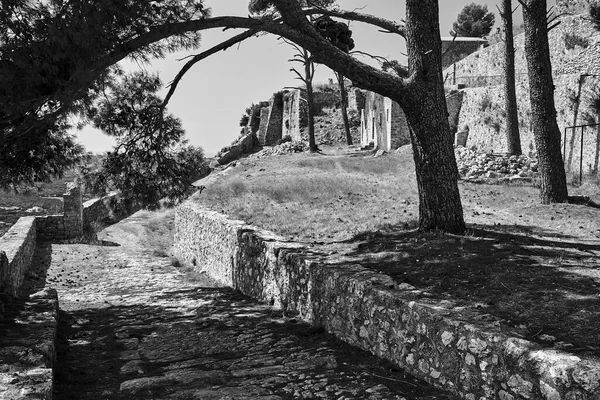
[501,0,522,155]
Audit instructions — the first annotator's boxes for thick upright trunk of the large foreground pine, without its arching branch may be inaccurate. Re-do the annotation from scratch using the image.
[393,0,465,233]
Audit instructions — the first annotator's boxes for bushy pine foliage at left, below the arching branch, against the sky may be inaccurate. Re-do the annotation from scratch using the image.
[82,72,204,209]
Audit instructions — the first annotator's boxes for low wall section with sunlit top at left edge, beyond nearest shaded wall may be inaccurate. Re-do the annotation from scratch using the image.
[0,217,36,296]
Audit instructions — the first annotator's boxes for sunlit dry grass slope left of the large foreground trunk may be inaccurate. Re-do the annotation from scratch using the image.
[198,150,418,242]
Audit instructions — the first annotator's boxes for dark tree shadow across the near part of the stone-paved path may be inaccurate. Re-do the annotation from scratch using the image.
[55,287,453,400]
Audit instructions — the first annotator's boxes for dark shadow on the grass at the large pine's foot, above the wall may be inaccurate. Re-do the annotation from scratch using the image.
[345,225,600,355]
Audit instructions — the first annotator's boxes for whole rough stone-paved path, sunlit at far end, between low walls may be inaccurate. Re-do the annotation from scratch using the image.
[30,213,452,400]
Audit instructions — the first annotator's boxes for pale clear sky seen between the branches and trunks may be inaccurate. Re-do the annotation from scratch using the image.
[74,0,555,156]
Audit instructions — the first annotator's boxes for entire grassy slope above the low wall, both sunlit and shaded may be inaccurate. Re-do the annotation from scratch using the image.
[196,149,600,355]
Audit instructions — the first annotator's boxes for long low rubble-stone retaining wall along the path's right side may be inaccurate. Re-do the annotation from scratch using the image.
[174,203,600,400]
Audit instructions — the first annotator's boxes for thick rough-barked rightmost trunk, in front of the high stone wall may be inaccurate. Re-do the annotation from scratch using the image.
[523,0,568,204]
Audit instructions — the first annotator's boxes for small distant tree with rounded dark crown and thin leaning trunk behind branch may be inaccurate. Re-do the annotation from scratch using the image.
[315,16,354,146]
